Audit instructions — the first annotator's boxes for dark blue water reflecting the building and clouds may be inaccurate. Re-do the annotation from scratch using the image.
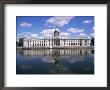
[16,49,94,74]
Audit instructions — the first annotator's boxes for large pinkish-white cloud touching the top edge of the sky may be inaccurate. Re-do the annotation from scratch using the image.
[46,16,73,27]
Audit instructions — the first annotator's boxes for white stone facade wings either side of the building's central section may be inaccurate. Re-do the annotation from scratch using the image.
[23,39,91,47]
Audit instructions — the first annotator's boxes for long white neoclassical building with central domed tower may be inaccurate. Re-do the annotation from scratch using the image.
[23,30,91,48]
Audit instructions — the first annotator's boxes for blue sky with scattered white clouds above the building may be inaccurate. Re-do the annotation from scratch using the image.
[16,16,94,40]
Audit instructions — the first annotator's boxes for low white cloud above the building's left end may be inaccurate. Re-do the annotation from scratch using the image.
[17,32,38,38]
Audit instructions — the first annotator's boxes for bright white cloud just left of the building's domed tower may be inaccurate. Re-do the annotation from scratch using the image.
[40,28,59,37]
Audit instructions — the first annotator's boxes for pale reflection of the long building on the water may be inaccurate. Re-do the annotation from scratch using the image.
[19,49,94,57]
